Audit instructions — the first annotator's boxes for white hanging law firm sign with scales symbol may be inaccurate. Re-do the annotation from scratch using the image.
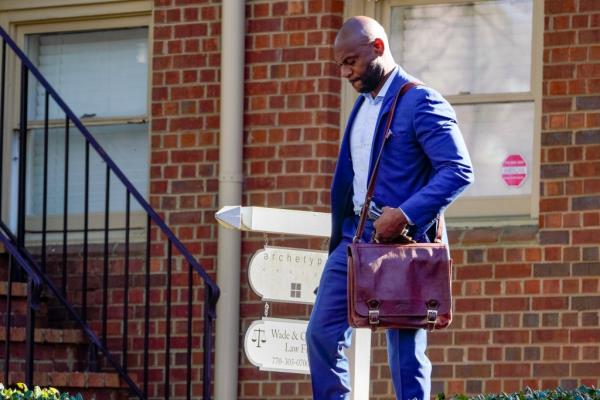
[244,318,309,374]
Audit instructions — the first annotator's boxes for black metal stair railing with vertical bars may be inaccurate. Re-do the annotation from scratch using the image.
[0,28,219,399]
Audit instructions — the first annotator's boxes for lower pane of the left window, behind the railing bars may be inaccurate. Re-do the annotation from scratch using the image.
[28,124,148,216]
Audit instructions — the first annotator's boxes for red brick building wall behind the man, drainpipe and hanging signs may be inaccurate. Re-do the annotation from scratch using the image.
[151,0,600,399]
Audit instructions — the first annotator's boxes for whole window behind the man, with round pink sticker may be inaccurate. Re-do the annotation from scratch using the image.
[375,0,542,218]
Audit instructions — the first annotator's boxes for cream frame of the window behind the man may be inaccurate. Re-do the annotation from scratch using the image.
[341,0,544,226]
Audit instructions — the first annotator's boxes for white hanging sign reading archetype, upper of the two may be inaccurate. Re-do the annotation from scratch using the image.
[248,246,327,304]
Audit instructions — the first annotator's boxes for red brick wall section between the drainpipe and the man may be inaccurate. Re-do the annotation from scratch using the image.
[238,0,343,399]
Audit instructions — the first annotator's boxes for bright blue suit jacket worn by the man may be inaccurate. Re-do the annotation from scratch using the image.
[329,66,473,252]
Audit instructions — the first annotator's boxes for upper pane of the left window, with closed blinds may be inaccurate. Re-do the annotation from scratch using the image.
[27,28,148,120]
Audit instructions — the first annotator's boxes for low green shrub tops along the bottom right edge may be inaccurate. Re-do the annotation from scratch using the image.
[437,386,600,400]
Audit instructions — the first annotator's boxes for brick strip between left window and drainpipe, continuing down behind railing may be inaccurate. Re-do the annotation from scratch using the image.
[151,0,221,398]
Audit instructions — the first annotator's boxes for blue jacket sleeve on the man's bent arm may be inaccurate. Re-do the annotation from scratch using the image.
[400,86,474,227]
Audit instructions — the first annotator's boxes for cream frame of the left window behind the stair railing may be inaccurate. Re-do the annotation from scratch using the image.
[0,0,153,243]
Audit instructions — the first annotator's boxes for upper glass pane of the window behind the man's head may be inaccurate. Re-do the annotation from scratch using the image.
[390,0,533,95]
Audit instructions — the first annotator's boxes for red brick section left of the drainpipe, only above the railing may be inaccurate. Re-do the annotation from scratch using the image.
[150,0,221,270]
